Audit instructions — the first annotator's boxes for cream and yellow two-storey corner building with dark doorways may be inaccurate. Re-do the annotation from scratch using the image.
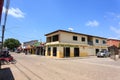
[45,30,107,58]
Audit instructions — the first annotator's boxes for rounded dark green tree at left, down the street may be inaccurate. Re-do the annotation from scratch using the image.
[4,38,21,50]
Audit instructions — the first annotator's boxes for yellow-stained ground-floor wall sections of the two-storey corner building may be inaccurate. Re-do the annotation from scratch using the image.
[45,46,107,58]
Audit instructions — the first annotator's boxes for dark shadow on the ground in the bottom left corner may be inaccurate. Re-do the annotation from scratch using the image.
[0,68,15,80]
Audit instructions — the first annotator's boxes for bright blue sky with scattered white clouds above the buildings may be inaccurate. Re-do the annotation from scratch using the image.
[0,0,120,42]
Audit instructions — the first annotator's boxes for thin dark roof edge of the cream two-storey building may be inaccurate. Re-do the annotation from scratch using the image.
[45,30,107,39]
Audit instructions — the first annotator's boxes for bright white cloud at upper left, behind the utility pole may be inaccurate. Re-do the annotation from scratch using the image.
[3,7,25,18]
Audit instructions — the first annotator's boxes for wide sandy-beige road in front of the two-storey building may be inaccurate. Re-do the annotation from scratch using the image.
[2,53,120,80]
